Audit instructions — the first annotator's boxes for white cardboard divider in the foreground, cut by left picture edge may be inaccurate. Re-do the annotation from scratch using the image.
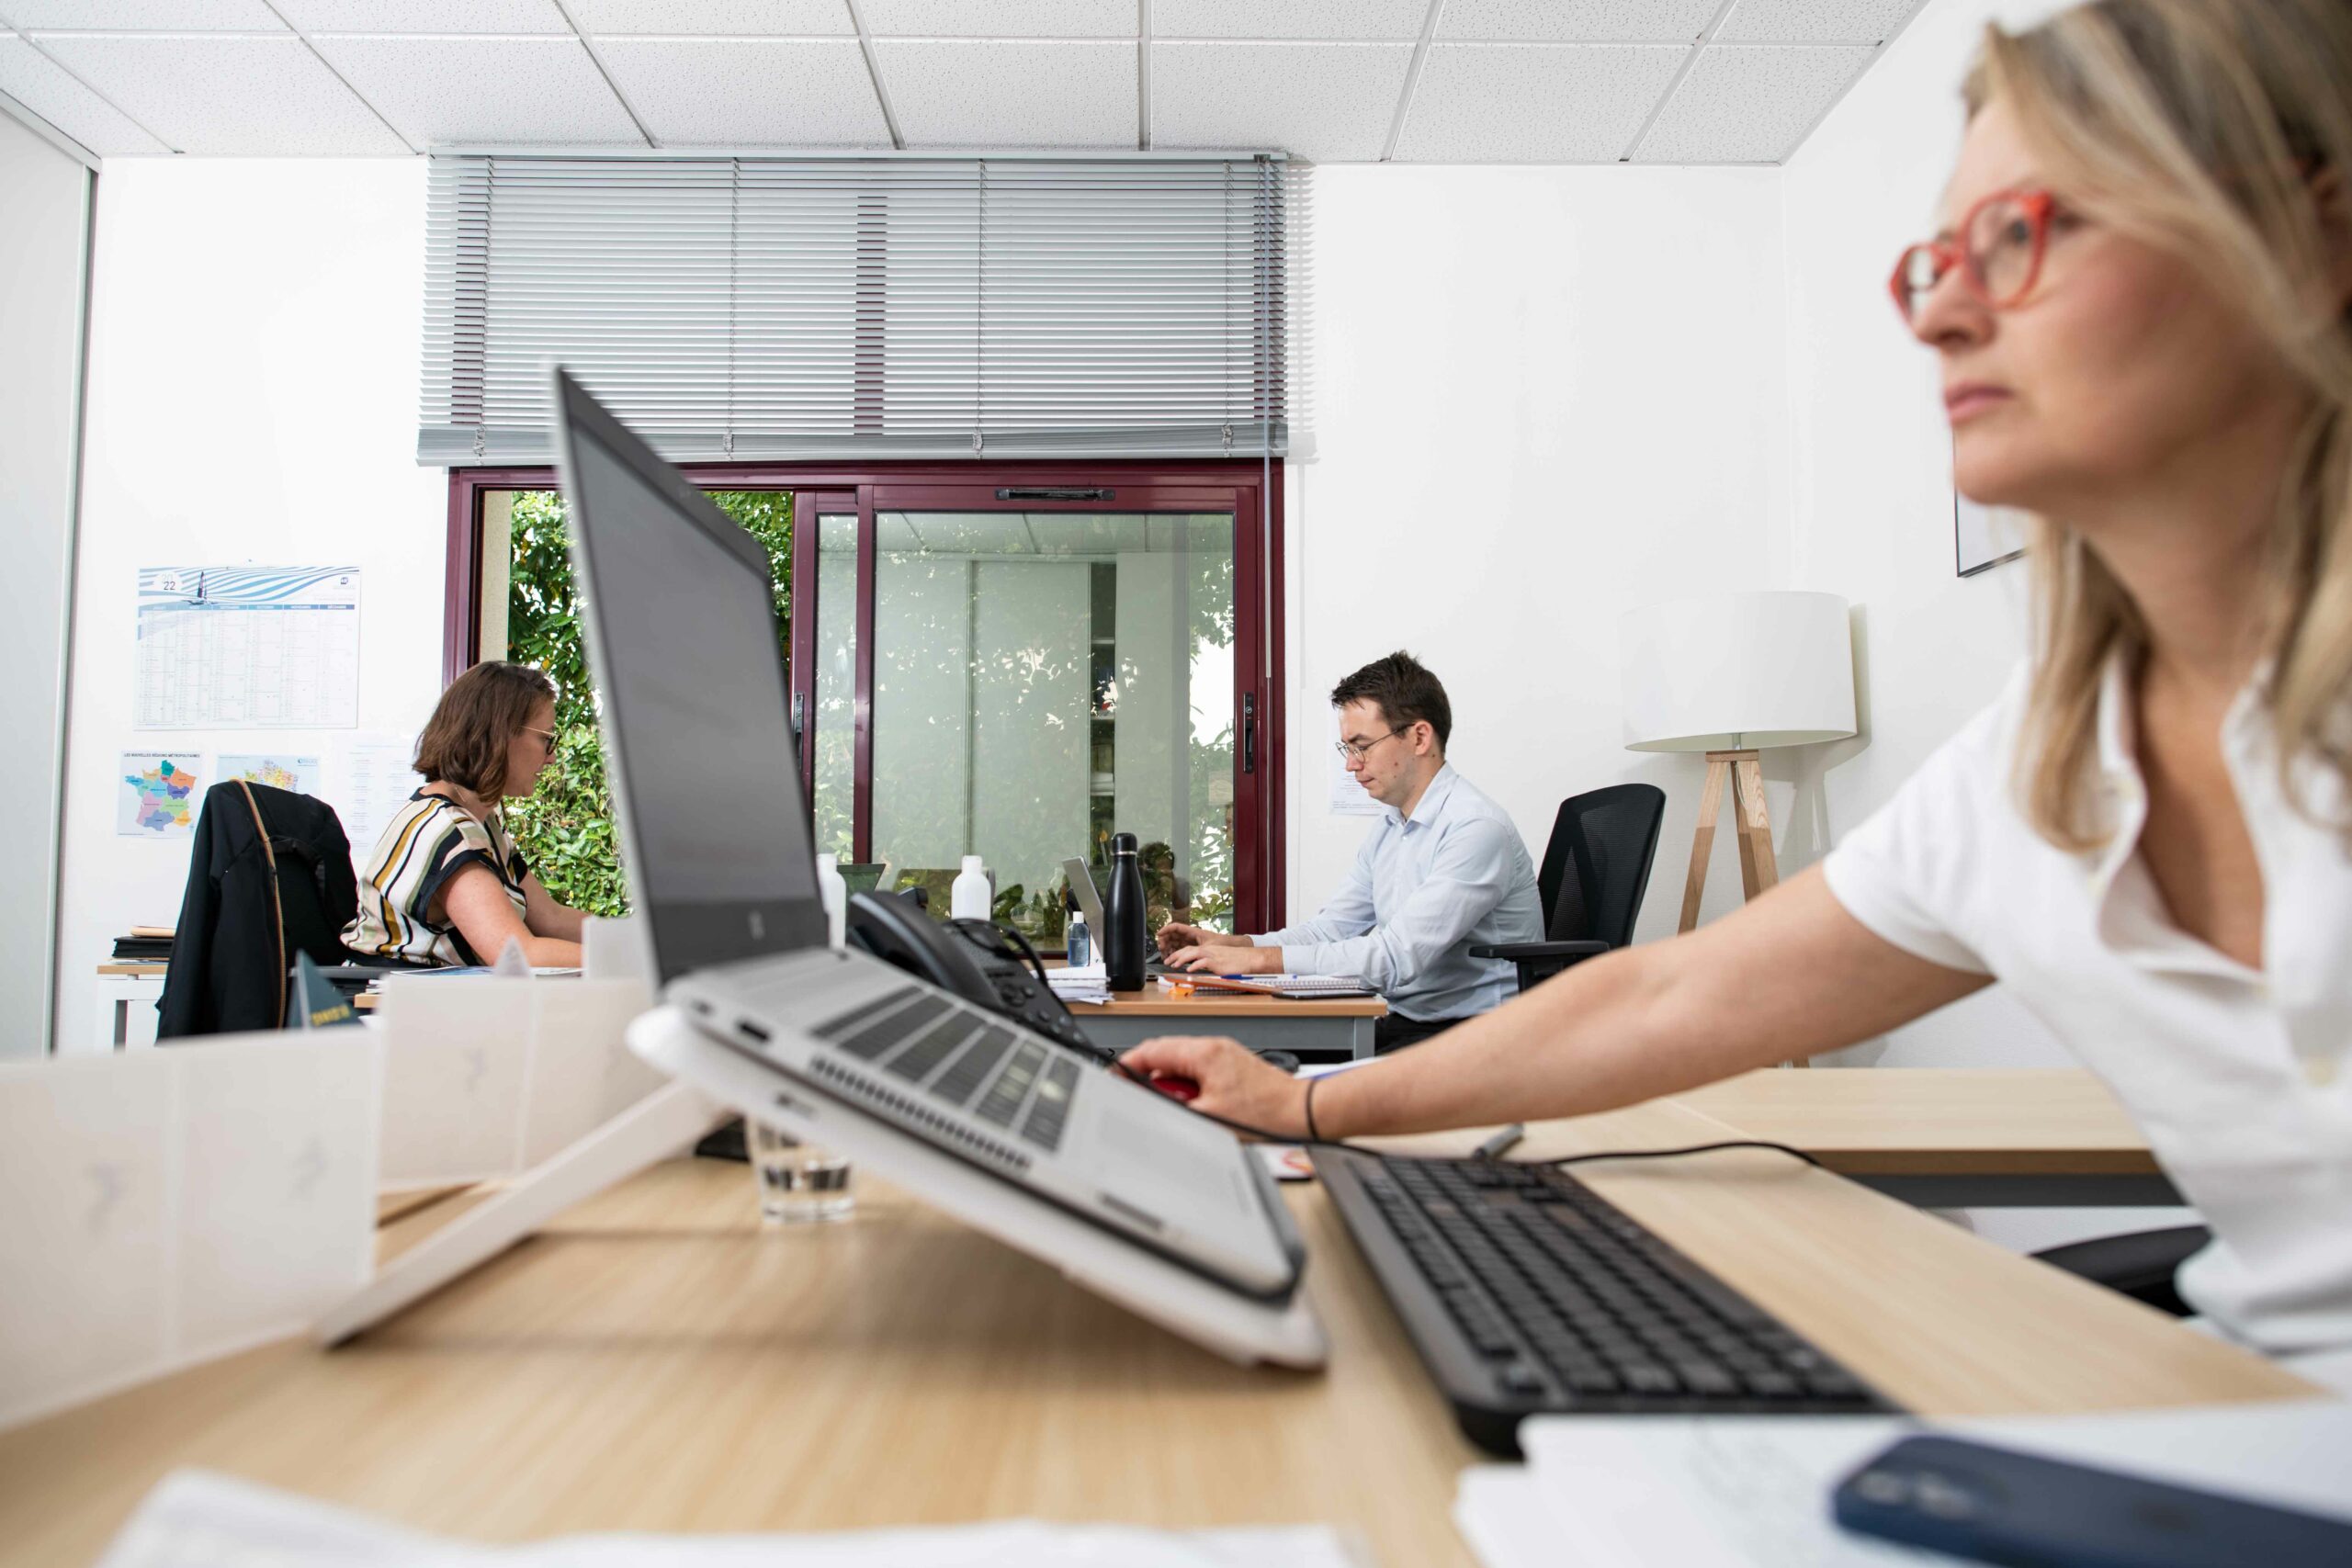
[0,1030,381,1427]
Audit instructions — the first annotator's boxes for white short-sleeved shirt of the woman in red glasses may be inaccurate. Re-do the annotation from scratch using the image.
[1823,663,2352,1352]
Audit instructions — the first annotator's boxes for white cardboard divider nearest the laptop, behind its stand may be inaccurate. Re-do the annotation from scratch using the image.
[374,976,668,1192]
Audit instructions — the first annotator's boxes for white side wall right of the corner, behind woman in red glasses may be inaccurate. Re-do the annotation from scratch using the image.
[1781,0,2072,1067]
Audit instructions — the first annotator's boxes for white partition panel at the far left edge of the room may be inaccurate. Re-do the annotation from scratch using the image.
[0,113,96,1058]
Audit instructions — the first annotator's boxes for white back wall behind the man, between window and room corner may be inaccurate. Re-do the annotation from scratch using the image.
[1284,164,1790,938]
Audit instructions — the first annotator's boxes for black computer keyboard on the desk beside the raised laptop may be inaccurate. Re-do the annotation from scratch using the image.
[1315,1149,1895,1455]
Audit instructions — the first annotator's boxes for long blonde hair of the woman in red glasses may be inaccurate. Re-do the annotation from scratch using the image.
[1966,0,2352,849]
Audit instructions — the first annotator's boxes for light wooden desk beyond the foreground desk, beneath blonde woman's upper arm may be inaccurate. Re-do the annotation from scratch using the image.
[1675,1067,2183,1208]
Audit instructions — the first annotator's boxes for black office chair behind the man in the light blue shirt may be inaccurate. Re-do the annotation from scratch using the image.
[1470,785,1665,992]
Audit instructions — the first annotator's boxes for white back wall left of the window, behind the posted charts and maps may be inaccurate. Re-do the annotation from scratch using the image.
[56,157,447,1051]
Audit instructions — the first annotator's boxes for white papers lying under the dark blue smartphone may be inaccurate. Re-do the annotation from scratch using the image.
[1453,1399,2352,1568]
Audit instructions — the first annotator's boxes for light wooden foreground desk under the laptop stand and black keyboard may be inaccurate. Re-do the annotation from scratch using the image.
[0,1100,2312,1568]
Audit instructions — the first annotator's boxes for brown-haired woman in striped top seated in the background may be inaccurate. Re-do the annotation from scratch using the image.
[344,660,581,968]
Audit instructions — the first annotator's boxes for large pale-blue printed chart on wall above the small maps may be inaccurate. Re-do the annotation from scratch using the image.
[136,567,360,728]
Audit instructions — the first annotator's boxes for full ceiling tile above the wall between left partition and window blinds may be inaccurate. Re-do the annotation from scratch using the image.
[40,33,412,157]
